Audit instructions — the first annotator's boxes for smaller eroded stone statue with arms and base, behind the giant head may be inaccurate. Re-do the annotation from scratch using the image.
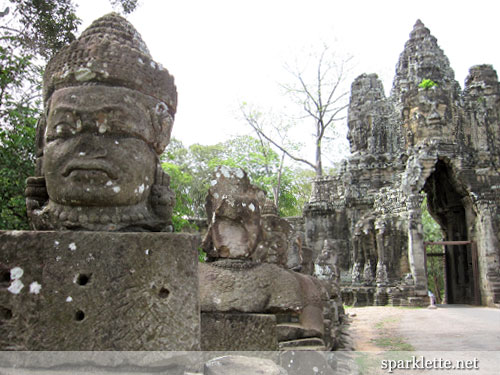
[199,167,343,350]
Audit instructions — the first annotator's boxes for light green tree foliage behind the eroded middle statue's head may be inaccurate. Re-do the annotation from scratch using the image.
[162,136,314,230]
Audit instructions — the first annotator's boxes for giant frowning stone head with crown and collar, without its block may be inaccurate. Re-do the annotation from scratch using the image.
[26,13,177,231]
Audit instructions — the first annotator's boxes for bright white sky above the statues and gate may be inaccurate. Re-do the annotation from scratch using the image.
[77,0,500,162]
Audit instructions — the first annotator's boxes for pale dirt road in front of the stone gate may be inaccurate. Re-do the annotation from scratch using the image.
[346,305,500,351]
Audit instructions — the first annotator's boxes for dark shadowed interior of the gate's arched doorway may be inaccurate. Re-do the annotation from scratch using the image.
[424,160,479,304]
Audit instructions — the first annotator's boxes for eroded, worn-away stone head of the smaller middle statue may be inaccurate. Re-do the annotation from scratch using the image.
[202,166,265,259]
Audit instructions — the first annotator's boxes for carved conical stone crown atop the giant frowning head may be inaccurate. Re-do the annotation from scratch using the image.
[43,13,177,117]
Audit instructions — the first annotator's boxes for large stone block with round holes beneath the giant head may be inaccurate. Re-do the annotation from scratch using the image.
[0,231,200,351]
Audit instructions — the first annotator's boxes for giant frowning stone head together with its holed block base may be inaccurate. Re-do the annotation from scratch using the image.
[0,13,200,350]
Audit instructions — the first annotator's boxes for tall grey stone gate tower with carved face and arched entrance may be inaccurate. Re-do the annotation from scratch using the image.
[304,21,500,306]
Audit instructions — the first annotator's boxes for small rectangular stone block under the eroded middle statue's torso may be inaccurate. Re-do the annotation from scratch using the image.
[201,312,278,351]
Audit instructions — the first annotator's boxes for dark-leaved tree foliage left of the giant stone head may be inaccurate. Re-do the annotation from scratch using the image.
[0,0,80,229]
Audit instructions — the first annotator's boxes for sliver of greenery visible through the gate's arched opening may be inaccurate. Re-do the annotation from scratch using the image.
[422,197,444,303]
